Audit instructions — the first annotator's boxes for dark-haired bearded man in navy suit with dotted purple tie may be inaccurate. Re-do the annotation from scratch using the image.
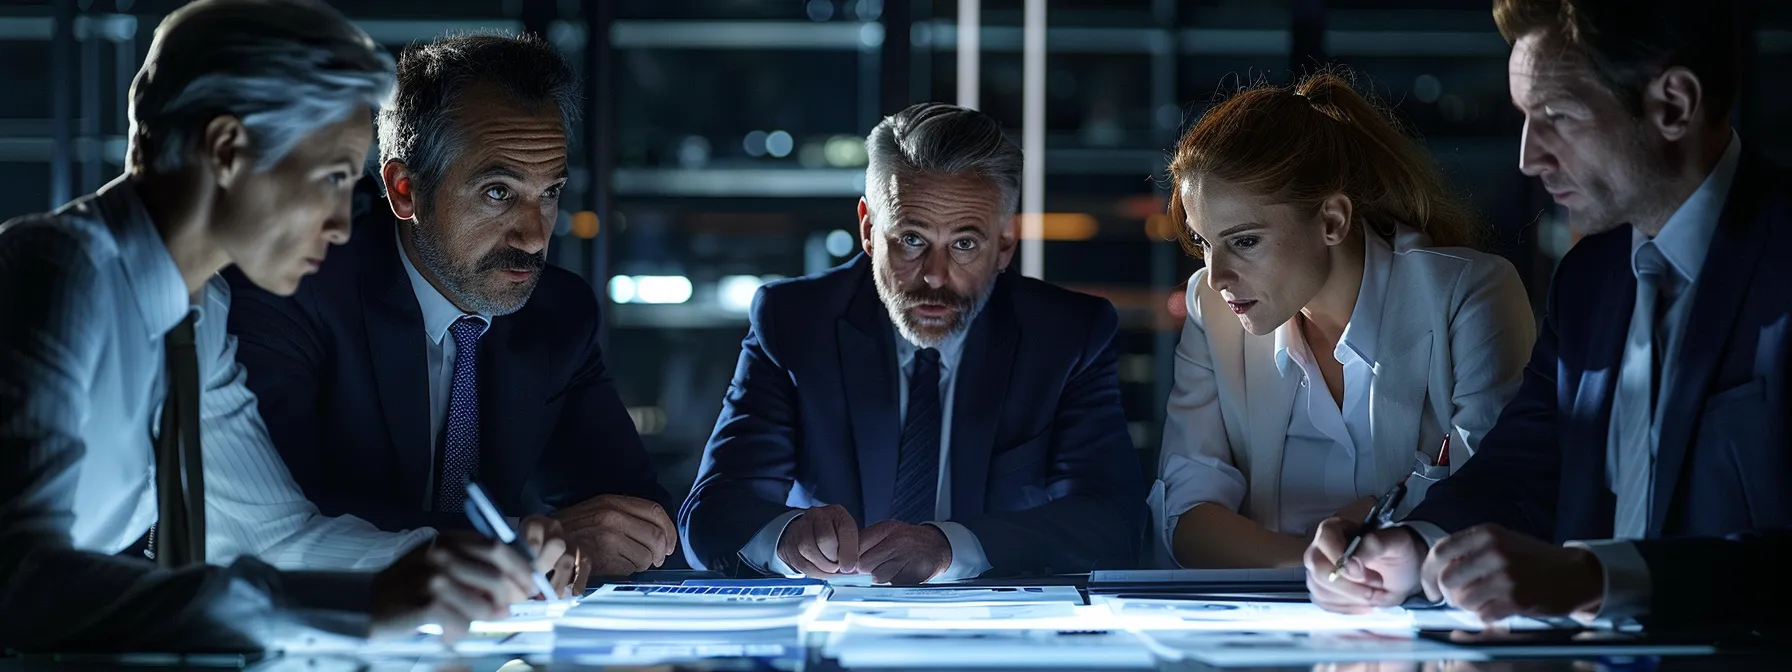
[229,36,677,575]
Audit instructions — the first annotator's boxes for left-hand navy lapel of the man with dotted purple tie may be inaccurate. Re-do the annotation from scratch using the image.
[360,224,434,505]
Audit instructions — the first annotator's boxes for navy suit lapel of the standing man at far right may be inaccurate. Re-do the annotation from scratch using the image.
[1649,156,1769,538]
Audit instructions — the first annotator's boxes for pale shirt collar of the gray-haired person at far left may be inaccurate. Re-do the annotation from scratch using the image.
[95,174,194,339]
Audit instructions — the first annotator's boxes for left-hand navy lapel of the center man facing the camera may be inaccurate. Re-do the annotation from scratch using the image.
[831,263,901,525]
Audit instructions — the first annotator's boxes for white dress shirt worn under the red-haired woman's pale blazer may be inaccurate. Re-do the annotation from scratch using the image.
[1163,235,1439,539]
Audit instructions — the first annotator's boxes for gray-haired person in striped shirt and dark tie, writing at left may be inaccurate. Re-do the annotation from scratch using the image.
[0,0,557,650]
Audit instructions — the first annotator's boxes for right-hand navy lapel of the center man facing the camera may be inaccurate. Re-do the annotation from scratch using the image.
[952,274,1020,520]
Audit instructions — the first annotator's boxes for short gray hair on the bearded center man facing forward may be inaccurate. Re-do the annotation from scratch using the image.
[866,102,1023,224]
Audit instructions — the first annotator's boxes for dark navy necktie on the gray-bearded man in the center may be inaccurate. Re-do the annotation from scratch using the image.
[891,348,939,525]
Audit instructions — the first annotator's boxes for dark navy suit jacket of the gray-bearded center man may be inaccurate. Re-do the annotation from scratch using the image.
[679,256,1145,575]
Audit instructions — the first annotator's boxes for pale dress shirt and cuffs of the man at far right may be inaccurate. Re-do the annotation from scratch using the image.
[1407,131,1742,622]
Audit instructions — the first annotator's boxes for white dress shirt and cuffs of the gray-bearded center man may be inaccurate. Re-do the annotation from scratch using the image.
[740,328,991,582]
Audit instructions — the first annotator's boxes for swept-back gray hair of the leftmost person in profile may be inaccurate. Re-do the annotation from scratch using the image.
[127,0,394,172]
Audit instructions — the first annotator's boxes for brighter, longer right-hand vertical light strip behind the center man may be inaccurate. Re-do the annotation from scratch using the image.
[1020,0,1045,278]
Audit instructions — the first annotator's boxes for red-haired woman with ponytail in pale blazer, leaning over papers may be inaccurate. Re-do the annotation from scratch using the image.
[1154,72,1536,568]
